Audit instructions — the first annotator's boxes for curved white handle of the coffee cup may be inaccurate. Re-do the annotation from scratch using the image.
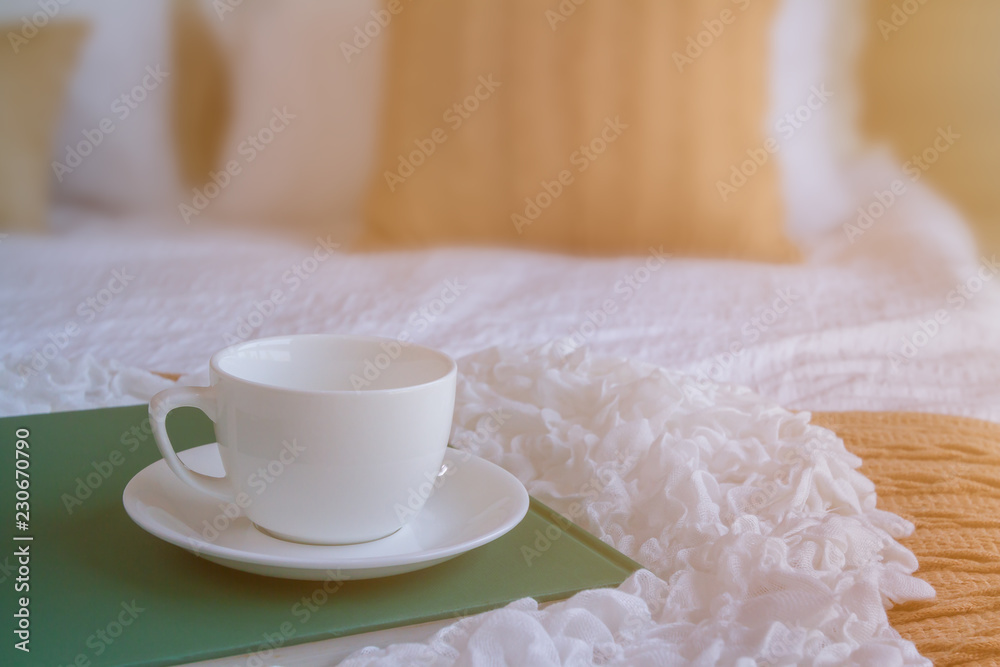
[149,387,236,501]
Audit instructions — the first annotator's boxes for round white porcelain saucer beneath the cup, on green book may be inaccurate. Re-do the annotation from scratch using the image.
[122,443,528,580]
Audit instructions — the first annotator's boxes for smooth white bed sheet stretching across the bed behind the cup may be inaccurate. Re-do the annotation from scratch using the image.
[0,159,1000,420]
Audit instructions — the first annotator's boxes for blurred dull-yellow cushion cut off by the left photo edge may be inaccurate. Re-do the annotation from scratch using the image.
[0,21,87,232]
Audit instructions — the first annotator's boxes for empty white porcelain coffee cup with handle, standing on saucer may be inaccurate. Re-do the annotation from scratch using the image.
[149,334,457,544]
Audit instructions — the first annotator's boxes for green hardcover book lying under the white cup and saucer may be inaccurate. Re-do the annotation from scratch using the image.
[0,405,640,667]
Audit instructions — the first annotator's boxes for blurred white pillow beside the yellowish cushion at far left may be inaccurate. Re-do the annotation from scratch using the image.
[53,0,181,219]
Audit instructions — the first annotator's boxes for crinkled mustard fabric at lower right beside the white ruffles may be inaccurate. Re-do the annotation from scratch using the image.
[812,412,1000,667]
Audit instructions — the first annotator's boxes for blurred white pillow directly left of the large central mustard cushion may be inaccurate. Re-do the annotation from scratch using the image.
[196,0,386,239]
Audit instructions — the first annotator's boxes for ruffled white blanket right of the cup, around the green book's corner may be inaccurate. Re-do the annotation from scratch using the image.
[345,344,934,667]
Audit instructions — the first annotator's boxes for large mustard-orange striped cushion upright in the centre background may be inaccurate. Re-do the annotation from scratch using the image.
[367,0,796,260]
